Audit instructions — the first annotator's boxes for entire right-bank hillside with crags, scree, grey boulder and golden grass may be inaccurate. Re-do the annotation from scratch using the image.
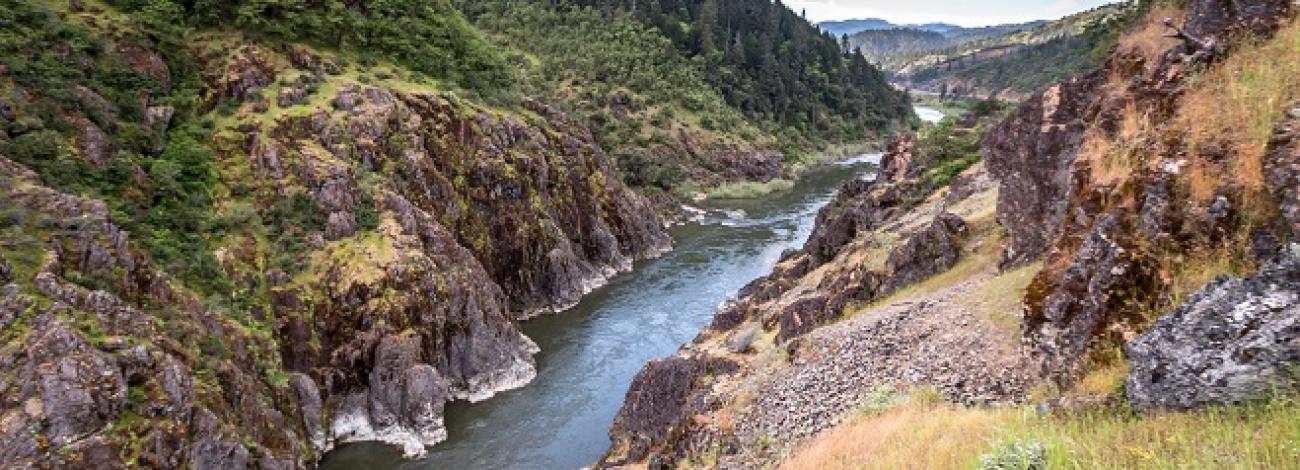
[606,0,1300,469]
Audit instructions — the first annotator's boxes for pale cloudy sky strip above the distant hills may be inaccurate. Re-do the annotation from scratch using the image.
[785,0,1113,26]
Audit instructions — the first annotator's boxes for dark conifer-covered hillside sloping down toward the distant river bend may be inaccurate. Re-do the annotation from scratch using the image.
[577,0,911,148]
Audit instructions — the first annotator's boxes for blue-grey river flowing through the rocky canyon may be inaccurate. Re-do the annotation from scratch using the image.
[321,109,943,470]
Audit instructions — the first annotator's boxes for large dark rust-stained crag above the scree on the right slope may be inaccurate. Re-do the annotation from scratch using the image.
[984,0,1291,386]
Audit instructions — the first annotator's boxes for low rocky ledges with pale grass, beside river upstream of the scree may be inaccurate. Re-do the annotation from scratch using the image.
[711,138,966,341]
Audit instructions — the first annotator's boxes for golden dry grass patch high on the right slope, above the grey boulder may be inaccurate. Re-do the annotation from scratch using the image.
[1177,22,1300,199]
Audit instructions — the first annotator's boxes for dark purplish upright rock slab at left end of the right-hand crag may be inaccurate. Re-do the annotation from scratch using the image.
[982,73,1105,267]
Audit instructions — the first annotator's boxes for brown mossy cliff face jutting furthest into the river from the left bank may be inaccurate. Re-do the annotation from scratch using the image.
[248,81,670,323]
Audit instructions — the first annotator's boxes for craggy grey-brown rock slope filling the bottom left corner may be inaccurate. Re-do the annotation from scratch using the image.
[0,158,311,469]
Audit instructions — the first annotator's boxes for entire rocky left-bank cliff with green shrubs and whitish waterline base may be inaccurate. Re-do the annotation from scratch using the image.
[0,3,671,469]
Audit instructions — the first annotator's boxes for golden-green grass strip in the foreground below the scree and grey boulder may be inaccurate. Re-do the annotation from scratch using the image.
[781,397,1300,470]
